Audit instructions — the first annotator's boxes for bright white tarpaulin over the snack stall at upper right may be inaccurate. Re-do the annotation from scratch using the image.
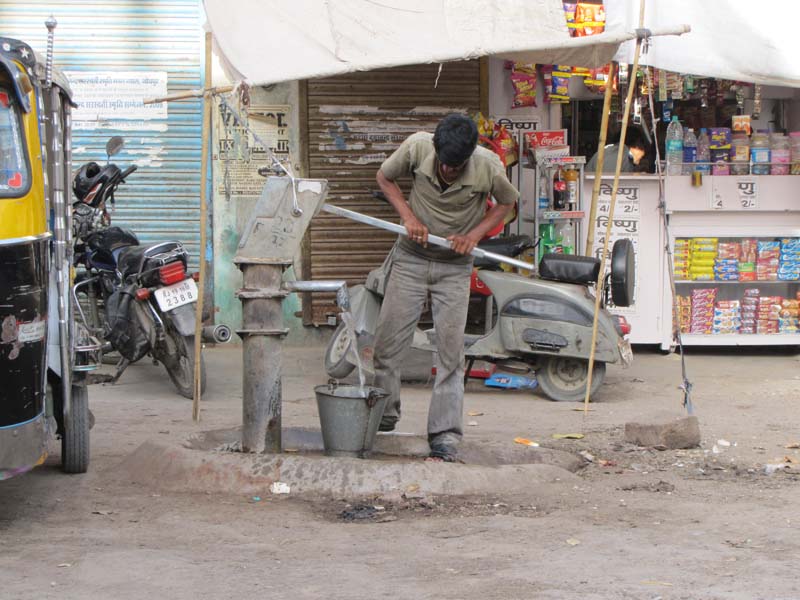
[605,0,800,87]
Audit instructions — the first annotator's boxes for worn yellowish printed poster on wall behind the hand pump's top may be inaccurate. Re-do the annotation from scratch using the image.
[213,104,290,197]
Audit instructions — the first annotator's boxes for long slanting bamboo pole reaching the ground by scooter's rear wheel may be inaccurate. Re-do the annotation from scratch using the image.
[583,0,646,412]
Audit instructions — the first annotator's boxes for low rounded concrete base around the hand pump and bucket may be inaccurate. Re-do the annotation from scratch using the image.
[118,429,584,499]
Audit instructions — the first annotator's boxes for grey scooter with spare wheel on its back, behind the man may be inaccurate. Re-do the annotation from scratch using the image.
[325,239,635,402]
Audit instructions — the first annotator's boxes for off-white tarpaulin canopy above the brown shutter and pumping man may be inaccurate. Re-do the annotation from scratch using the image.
[205,0,633,85]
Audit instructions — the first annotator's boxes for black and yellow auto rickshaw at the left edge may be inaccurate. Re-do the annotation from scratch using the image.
[0,22,99,480]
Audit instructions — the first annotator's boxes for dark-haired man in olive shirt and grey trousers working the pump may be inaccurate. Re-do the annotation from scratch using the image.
[374,114,519,462]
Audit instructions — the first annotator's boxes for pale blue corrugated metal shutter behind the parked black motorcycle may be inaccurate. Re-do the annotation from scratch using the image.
[0,0,203,267]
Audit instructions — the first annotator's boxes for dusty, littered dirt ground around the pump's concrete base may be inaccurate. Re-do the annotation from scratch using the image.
[0,346,800,600]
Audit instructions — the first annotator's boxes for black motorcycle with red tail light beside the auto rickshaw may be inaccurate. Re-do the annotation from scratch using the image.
[73,137,209,398]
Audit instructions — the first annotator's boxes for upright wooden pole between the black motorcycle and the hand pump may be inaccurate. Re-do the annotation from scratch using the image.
[192,31,212,422]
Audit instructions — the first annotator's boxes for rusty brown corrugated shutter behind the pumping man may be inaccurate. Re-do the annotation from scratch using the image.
[303,60,481,324]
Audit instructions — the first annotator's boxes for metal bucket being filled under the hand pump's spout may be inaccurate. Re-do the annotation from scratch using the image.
[314,383,388,458]
